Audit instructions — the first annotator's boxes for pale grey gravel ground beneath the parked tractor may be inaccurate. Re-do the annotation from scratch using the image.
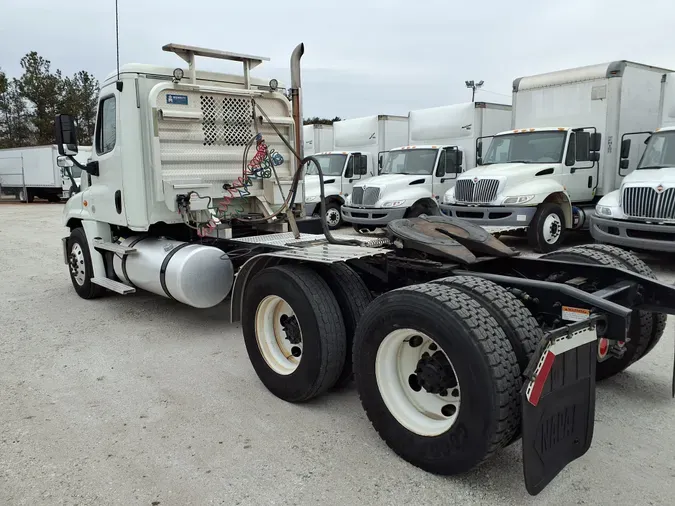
[0,203,675,506]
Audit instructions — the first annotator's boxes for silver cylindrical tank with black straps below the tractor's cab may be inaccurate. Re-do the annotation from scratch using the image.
[113,236,234,308]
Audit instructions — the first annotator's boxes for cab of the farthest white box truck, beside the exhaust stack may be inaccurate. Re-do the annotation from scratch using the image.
[305,151,376,229]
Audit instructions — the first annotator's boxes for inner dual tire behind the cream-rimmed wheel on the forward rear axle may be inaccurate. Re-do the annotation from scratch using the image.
[319,264,373,388]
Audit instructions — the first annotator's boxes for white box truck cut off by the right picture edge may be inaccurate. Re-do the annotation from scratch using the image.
[591,73,675,253]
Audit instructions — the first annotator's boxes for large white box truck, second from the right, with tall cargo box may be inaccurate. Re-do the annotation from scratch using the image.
[441,61,667,252]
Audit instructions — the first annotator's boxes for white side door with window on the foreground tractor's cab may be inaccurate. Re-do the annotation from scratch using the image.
[85,85,127,225]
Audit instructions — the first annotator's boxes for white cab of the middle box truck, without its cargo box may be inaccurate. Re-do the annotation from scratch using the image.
[342,145,465,231]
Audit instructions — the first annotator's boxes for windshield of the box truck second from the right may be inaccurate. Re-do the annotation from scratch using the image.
[482,131,567,165]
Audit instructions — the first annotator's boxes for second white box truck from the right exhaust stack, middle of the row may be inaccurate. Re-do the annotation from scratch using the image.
[342,102,511,232]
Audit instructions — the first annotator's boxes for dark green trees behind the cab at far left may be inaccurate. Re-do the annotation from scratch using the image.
[0,51,99,148]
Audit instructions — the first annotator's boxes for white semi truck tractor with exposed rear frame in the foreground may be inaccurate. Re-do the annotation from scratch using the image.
[55,44,675,494]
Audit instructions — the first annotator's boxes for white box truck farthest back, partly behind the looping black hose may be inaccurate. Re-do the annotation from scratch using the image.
[305,115,408,229]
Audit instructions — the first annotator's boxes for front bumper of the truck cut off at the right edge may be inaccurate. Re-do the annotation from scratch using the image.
[591,213,675,253]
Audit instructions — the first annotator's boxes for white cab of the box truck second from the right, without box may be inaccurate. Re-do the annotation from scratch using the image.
[441,127,601,249]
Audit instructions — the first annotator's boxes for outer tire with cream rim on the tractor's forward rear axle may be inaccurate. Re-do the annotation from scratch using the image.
[242,265,346,402]
